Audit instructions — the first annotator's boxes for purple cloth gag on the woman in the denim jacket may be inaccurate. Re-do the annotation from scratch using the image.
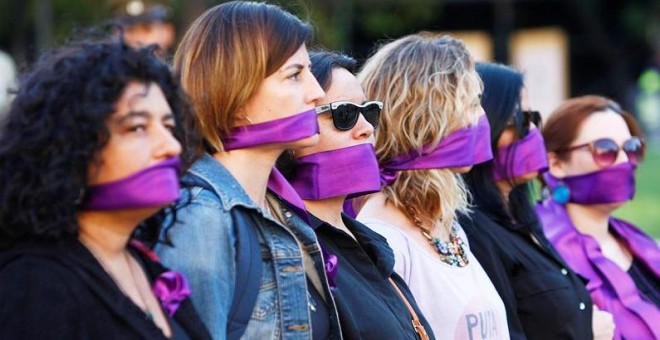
[223,109,319,150]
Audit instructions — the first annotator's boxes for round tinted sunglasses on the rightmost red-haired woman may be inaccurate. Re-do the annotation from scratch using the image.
[558,136,646,167]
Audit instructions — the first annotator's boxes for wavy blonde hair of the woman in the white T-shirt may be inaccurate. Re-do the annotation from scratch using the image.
[358,32,483,230]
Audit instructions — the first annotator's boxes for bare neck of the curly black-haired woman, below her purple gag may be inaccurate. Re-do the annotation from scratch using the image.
[78,210,145,258]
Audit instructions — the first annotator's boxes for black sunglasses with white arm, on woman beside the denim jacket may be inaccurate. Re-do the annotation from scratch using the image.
[316,100,383,131]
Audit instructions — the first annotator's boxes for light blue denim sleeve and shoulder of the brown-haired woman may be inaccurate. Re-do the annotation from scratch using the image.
[156,191,236,339]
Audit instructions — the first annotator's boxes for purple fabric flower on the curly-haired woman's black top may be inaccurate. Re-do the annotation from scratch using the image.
[152,271,191,317]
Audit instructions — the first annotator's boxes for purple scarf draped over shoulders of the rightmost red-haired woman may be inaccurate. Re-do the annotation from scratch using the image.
[536,199,660,339]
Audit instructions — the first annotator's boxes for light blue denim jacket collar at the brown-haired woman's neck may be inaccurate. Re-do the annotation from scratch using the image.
[189,153,259,211]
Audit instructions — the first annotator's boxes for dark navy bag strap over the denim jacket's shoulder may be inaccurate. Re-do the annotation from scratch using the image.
[185,174,262,340]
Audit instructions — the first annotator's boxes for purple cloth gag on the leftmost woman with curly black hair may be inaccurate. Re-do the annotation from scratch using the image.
[82,157,181,210]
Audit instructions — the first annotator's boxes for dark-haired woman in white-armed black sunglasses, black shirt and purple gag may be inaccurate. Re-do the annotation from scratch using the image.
[280,52,430,339]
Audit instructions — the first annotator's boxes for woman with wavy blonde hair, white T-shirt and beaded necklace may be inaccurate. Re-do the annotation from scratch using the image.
[358,33,509,339]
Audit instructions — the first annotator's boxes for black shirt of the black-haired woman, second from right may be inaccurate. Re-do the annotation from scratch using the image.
[459,209,593,339]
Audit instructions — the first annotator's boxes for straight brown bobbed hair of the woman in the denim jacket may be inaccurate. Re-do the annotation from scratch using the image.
[174,1,312,152]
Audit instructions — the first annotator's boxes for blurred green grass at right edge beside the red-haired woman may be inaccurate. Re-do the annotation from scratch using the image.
[614,146,660,239]
